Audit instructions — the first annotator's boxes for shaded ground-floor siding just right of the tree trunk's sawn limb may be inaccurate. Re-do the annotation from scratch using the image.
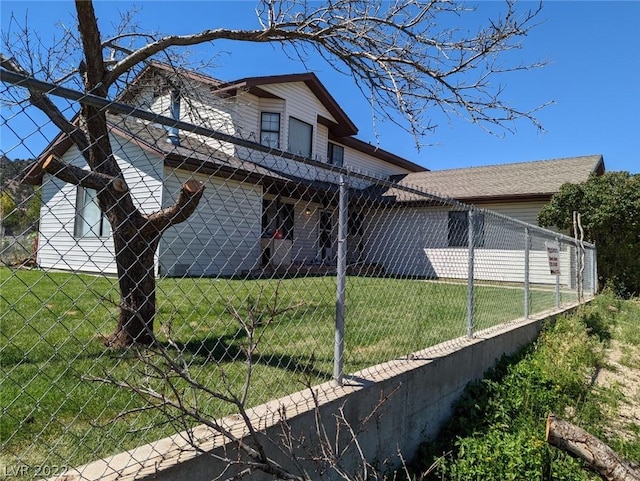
[159,169,262,276]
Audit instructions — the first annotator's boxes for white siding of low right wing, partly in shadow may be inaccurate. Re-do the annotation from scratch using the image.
[365,202,574,285]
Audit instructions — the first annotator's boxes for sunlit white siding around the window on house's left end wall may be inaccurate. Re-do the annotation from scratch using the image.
[38,139,162,274]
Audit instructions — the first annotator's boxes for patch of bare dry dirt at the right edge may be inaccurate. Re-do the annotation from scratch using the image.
[595,340,640,439]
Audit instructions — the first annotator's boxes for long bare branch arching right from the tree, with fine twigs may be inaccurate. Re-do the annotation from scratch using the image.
[99,0,547,141]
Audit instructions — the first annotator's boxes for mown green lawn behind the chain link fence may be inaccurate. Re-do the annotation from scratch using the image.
[0,268,568,467]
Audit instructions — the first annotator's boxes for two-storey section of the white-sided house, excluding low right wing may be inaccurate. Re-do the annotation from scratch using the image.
[29,64,426,276]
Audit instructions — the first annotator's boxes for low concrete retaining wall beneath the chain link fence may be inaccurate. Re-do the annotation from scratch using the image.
[58,306,575,481]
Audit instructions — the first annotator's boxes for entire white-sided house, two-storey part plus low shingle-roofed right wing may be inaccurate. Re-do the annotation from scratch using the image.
[29,63,604,277]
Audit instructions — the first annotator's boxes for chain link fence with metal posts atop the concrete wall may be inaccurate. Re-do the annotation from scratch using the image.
[0,72,597,477]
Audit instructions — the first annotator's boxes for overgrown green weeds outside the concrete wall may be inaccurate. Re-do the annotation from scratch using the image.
[414,293,640,481]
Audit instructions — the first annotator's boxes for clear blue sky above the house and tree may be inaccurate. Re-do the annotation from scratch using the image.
[0,0,640,173]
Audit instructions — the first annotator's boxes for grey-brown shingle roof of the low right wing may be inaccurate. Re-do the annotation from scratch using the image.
[386,154,604,202]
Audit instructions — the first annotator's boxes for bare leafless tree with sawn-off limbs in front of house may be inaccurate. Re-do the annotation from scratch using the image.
[0,0,541,346]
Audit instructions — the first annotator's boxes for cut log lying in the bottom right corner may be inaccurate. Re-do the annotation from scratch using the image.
[546,414,640,481]
